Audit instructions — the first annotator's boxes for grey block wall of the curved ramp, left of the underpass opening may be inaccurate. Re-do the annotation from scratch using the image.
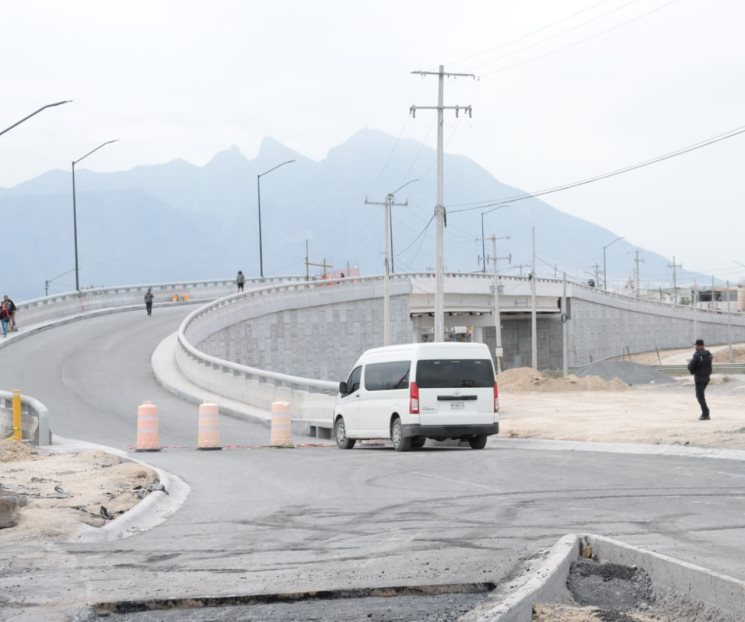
[198,294,414,382]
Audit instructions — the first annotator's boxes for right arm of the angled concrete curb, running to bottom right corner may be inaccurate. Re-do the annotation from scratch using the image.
[583,535,745,622]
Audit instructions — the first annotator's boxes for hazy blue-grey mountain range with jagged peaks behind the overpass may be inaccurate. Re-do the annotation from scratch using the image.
[0,130,688,300]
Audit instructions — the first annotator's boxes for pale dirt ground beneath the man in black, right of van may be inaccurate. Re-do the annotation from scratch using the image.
[499,370,745,449]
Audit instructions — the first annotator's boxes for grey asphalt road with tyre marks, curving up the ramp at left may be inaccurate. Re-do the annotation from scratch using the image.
[0,308,745,619]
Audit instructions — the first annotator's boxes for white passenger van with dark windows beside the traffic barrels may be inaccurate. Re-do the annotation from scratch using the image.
[334,343,499,451]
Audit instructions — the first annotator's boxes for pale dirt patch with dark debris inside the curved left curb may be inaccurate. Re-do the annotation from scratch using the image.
[0,441,156,545]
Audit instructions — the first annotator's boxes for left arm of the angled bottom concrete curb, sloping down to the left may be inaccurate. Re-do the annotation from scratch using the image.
[458,534,579,622]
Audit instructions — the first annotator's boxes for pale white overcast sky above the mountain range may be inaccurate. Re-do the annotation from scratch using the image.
[0,0,745,280]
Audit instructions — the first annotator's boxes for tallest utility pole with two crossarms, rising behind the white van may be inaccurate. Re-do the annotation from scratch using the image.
[409,65,476,341]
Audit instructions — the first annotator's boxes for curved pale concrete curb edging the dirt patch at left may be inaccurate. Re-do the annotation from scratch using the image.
[42,436,191,542]
